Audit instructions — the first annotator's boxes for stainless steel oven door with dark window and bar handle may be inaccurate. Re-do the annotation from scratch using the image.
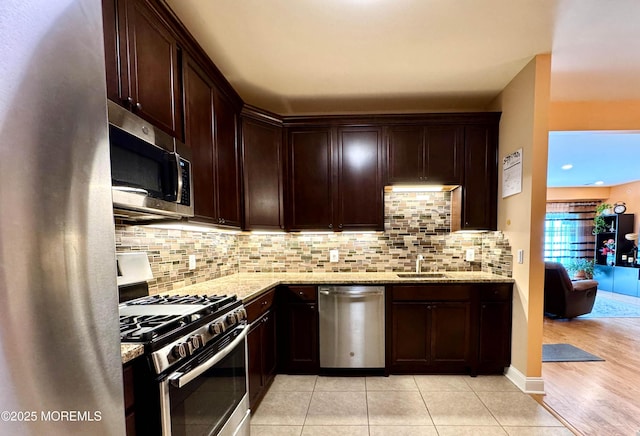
[160,325,249,436]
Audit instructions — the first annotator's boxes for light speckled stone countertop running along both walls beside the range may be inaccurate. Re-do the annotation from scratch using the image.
[122,271,514,363]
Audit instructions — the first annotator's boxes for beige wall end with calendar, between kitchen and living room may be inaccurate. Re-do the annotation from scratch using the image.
[491,55,551,384]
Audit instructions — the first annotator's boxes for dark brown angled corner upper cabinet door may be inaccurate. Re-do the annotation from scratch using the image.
[242,118,284,230]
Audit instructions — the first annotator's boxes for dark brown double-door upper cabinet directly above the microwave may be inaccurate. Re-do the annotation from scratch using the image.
[103,0,182,139]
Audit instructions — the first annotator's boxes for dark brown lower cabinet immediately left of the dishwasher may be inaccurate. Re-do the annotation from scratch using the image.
[278,286,320,374]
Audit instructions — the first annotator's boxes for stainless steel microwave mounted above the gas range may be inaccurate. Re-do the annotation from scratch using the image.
[107,101,193,221]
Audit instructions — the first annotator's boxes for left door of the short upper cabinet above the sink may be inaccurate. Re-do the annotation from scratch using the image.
[387,126,425,183]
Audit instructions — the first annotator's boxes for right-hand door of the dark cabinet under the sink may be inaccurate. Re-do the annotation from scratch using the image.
[429,302,471,370]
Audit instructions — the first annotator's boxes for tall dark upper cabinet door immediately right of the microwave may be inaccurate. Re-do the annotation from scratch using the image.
[183,56,216,222]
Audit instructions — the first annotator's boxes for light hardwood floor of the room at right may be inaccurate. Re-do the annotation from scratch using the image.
[542,318,640,436]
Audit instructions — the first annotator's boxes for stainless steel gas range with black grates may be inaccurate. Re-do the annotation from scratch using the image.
[119,295,249,436]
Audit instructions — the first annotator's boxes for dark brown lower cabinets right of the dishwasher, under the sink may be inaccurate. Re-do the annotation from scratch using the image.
[387,284,512,375]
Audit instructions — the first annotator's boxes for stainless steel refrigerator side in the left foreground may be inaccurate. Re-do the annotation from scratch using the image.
[0,0,125,435]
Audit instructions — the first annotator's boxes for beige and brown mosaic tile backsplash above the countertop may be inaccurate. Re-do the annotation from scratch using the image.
[116,192,512,293]
